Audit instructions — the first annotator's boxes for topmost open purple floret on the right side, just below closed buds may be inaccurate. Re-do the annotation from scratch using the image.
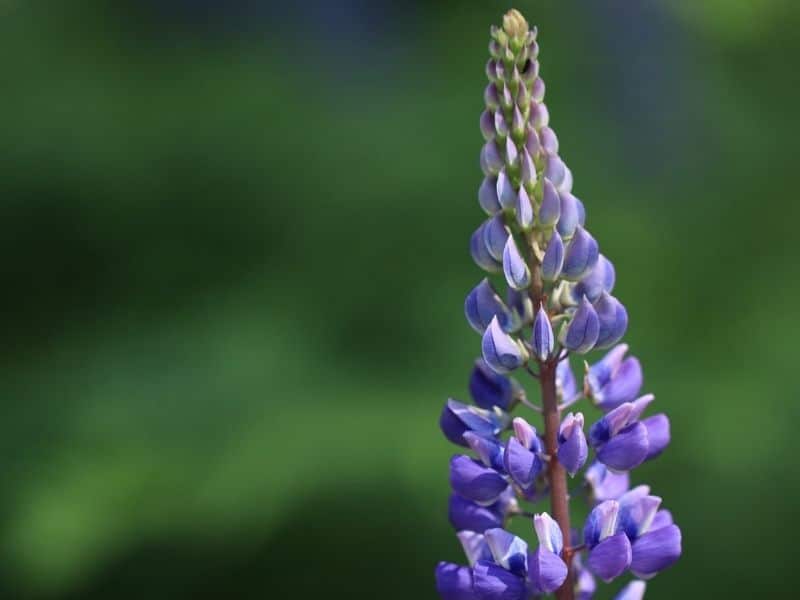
[584,344,642,411]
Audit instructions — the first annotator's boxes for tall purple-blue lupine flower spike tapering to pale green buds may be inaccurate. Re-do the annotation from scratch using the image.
[435,10,681,600]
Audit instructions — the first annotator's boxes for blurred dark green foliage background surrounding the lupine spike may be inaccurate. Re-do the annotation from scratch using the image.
[0,0,800,600]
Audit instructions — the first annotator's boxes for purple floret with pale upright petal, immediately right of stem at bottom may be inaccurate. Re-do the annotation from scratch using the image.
[583,500,632,582]
